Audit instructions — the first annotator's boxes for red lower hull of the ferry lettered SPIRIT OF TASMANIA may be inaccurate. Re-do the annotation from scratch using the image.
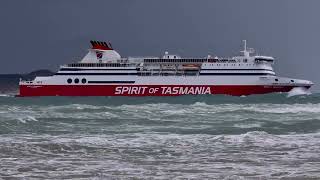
[18,85,310,97]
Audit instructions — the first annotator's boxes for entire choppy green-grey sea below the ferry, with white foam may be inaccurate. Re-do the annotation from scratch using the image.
[0,88,320,180]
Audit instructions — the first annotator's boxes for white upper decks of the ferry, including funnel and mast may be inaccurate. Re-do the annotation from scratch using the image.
[57,39,275,75]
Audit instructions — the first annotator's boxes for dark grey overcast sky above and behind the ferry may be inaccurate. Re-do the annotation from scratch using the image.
[0,0,320,89]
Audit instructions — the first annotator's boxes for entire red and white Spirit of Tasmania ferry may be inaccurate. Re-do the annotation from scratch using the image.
[18,41,313,96]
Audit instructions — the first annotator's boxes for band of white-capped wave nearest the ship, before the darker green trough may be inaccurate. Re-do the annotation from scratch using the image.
[0,102,320,120]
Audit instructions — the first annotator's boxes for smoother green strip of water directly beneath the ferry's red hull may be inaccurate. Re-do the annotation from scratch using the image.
[0,93,320,106]
